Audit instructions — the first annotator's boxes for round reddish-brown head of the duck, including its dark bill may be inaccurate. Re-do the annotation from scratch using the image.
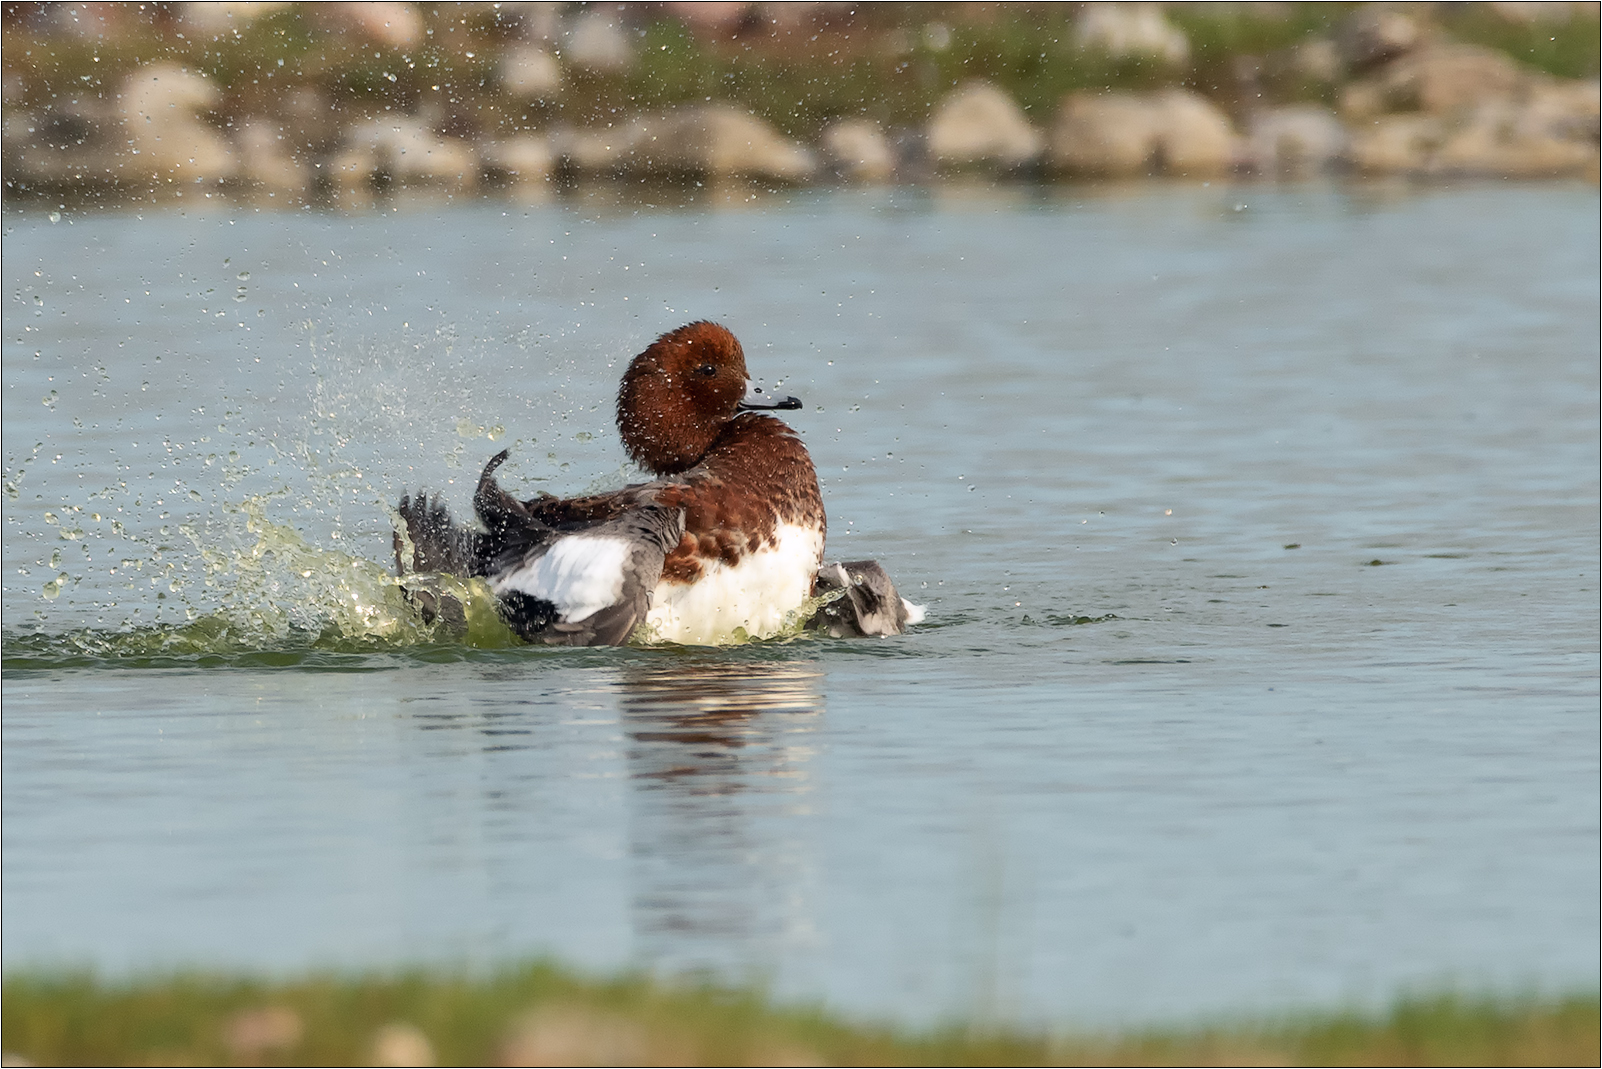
[617,321,801,474]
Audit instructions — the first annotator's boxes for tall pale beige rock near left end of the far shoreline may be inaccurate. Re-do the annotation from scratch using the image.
[120,63,237,181]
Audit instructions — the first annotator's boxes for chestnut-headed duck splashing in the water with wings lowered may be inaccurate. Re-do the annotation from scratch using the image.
[394,321,921,646]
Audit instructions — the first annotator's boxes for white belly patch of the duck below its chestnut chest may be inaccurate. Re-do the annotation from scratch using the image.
[646,524,823,646]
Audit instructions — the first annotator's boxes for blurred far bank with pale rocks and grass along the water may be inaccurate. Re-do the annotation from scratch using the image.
[3,3,1599,207]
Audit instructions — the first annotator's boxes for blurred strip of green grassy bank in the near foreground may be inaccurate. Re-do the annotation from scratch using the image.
[3,965,1599,1066]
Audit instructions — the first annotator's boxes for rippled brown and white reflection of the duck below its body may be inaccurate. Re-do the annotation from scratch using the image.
[622,662,823,978]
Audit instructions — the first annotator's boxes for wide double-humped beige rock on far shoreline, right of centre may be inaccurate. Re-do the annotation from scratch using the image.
[1049,90,1240,176]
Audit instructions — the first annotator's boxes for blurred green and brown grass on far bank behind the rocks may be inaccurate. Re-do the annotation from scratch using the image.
[3,3,1602,138]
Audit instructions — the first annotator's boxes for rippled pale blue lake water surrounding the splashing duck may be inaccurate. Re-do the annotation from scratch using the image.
[3,183,1599,1024]
